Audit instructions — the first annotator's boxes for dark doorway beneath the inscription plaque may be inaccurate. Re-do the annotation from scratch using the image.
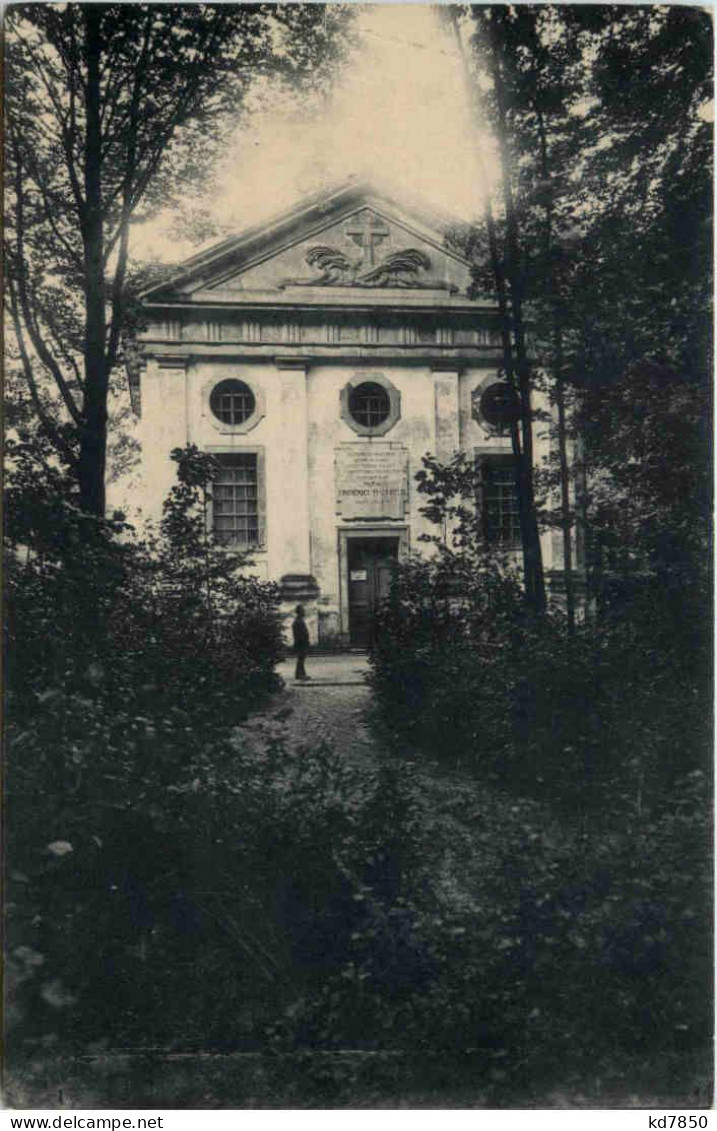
[348,538,398,648]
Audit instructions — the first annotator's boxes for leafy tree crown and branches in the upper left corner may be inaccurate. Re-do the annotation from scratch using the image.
[6,3,348,516]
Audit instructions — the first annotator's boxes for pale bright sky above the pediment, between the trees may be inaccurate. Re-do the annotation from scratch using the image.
[136,3,488,260]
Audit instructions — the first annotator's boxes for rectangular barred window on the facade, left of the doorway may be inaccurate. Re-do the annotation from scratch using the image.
[213,452,261,550]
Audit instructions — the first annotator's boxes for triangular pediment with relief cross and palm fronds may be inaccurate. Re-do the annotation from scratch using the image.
[142,184,470,303]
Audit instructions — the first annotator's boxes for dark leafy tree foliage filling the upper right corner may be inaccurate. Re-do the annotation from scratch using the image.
[451,5,712,623]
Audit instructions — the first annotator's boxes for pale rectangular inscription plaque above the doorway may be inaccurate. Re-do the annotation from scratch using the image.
[336,443,408,519]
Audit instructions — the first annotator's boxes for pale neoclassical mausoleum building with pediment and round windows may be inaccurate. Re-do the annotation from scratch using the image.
[132,182,553,646]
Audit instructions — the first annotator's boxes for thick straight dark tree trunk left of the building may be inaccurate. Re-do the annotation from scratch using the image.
[78,3,110,517]
